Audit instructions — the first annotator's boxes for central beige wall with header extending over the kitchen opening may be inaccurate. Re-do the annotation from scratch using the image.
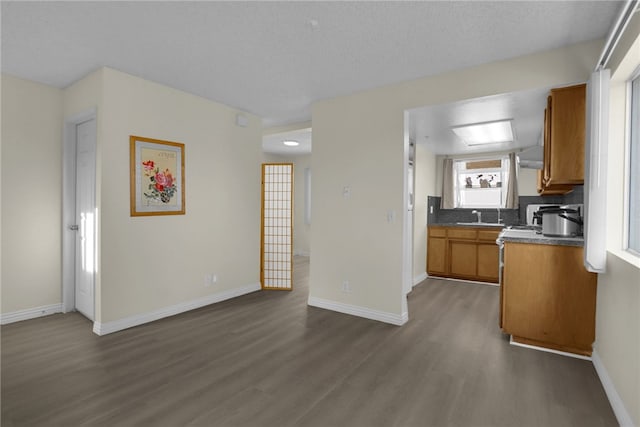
[310,41,602,318]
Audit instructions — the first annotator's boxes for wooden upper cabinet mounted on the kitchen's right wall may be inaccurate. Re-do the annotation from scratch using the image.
[538,84,586,195]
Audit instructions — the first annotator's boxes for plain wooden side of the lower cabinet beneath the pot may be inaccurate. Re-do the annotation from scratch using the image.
[501,242,597,356]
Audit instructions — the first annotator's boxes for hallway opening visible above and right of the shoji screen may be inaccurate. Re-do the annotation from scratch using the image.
[262,122,312,290]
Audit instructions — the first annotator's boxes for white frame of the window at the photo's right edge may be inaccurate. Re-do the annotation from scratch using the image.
[622,66,640,257]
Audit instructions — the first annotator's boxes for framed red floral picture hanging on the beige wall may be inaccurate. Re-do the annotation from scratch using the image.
[129,135,185,216]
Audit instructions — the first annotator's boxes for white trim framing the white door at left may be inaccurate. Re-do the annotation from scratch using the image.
[61,108,99,317]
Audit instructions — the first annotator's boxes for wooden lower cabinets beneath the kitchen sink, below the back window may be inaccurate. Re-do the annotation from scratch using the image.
[427,226,501,283]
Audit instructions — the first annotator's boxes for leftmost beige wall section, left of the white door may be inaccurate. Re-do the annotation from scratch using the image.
[1,74,62,314]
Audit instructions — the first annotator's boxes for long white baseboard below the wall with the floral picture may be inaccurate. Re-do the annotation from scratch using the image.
[93,283,261,335]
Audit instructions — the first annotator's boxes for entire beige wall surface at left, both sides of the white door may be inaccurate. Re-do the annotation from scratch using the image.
[2,68,261,323]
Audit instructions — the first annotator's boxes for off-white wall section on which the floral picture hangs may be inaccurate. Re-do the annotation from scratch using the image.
[99,68,261,322]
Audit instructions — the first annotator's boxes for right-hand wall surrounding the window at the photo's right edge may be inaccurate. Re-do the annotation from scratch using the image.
[595,20,640,426]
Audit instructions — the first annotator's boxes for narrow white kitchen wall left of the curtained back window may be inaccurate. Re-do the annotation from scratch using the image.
[413,144,436,284]
